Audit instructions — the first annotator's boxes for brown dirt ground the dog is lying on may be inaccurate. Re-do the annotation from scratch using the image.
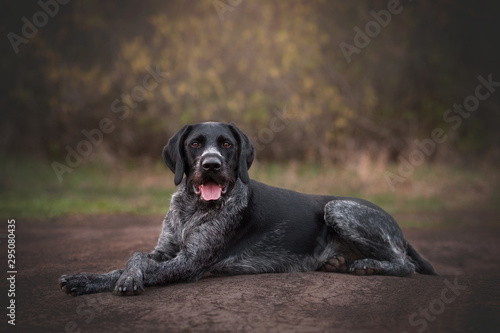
[0,212,500,333]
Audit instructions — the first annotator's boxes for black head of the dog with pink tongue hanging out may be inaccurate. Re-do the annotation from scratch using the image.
[163,122,254,201]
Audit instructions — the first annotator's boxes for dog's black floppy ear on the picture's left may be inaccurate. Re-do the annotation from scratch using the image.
[163,125,191,185]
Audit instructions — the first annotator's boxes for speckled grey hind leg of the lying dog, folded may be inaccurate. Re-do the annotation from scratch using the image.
[323,199,415,276]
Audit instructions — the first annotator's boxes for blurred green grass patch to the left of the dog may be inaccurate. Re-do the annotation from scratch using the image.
[0,160,174,218]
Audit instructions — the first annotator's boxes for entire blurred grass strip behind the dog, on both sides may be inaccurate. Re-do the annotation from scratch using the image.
[0,159,500,226]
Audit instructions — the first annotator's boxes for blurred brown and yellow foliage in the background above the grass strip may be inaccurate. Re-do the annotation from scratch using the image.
[0,0,500,163]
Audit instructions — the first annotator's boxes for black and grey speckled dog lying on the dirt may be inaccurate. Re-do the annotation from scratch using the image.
[60,122,437,296]
